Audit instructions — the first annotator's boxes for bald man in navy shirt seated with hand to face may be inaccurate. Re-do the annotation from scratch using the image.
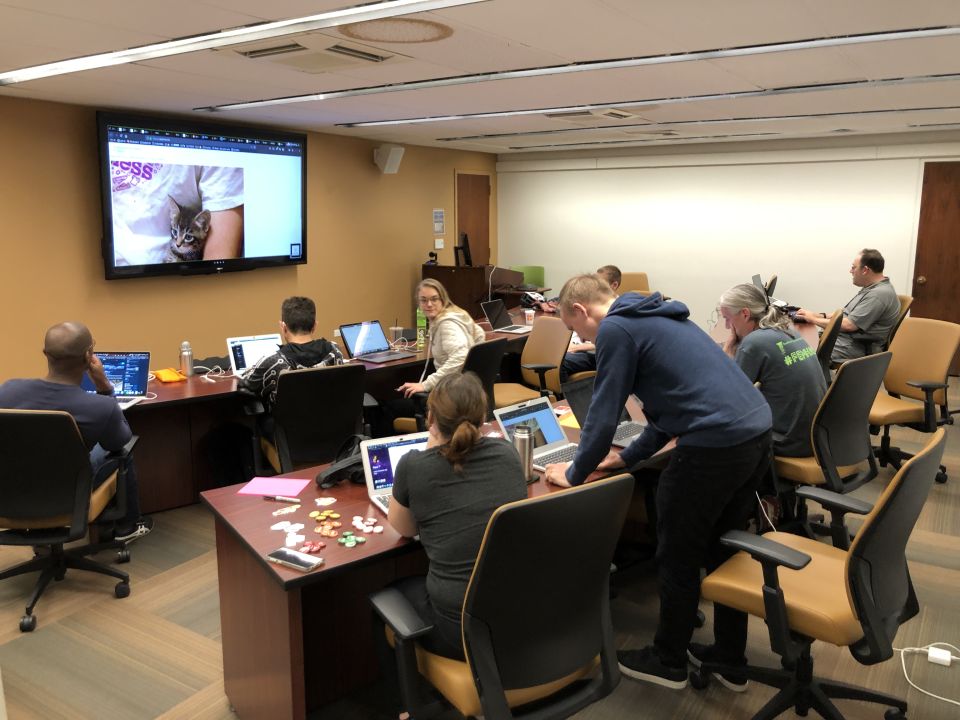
[0,322,153,542]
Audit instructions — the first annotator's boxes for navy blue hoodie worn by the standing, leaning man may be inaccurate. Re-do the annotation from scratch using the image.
[567,293,772,485]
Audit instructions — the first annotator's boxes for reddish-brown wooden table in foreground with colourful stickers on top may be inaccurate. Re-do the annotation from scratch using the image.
[201,426,673,720]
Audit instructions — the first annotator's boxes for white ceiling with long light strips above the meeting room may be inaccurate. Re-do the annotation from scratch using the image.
[0,0,960,154]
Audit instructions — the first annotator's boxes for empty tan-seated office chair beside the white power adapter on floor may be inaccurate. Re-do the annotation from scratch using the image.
[691,428,946,720]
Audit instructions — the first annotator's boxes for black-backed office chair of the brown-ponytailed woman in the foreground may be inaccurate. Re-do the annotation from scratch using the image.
[371,475,634,720]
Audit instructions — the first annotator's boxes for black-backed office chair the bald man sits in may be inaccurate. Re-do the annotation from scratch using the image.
[0,410,137,632]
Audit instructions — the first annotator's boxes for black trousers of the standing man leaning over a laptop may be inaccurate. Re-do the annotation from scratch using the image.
[654,432,770,667]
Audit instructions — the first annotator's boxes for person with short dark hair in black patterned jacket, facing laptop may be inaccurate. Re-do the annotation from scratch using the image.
[240,296,343,410]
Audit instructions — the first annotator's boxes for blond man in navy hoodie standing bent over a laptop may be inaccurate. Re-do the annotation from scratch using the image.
[545,275,772,691]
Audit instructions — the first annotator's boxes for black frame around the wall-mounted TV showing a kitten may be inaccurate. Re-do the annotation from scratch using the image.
[97,110,307,280]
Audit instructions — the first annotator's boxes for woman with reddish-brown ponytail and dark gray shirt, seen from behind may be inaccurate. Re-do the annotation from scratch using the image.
[389,372,524,660]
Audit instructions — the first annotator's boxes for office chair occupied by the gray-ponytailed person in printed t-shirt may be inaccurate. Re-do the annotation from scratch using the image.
[773,352,891,547]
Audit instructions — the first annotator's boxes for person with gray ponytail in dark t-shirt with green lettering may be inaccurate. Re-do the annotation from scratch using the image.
[720,283,827,457]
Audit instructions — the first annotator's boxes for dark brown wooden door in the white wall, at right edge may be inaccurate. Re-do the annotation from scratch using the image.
[910,162,960,375]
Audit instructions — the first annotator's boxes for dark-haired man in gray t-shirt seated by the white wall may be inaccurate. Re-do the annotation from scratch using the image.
[796,248,900,362]
